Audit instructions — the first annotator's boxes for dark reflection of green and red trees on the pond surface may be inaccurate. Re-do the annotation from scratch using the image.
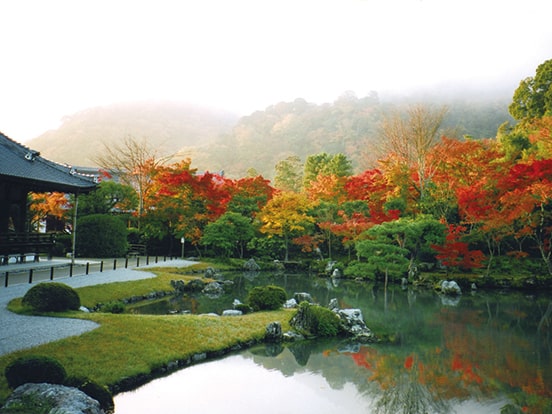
[246,291,552,413]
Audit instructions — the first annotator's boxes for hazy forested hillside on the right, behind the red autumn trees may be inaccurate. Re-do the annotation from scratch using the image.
[188,93,512,178]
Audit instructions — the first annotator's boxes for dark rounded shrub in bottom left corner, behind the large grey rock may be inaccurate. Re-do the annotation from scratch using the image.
[4,356,67,389]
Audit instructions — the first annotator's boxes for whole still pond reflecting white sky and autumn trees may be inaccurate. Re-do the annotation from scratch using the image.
[115,273,552,414]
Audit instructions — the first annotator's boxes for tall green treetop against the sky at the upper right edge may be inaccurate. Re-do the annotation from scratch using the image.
[508,59,552,123]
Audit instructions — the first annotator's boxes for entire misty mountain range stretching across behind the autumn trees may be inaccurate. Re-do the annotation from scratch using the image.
[27,92,512,179]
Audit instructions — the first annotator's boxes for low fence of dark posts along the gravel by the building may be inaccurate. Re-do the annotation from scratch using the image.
[0,256,176,287]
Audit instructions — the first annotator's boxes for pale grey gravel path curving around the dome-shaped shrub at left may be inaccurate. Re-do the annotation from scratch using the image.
[0,260,194,355]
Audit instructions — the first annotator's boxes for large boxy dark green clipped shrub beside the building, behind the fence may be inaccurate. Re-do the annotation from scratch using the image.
[76,214,128,257]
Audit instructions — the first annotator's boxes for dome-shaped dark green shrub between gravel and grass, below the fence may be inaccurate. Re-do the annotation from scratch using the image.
[22,282,80,312]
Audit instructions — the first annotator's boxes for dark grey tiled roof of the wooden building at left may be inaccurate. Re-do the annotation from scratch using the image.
[0,133,96,193]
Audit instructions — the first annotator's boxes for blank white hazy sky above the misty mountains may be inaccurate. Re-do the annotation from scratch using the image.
[0,0,552,141]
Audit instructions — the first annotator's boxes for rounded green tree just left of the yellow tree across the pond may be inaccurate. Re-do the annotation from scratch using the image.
[201,212,254,258]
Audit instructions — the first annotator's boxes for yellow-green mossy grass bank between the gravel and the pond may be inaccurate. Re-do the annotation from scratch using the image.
[0,269,291,403]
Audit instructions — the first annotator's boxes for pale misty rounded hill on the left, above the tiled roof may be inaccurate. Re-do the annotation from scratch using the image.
[26,101,238,166]
